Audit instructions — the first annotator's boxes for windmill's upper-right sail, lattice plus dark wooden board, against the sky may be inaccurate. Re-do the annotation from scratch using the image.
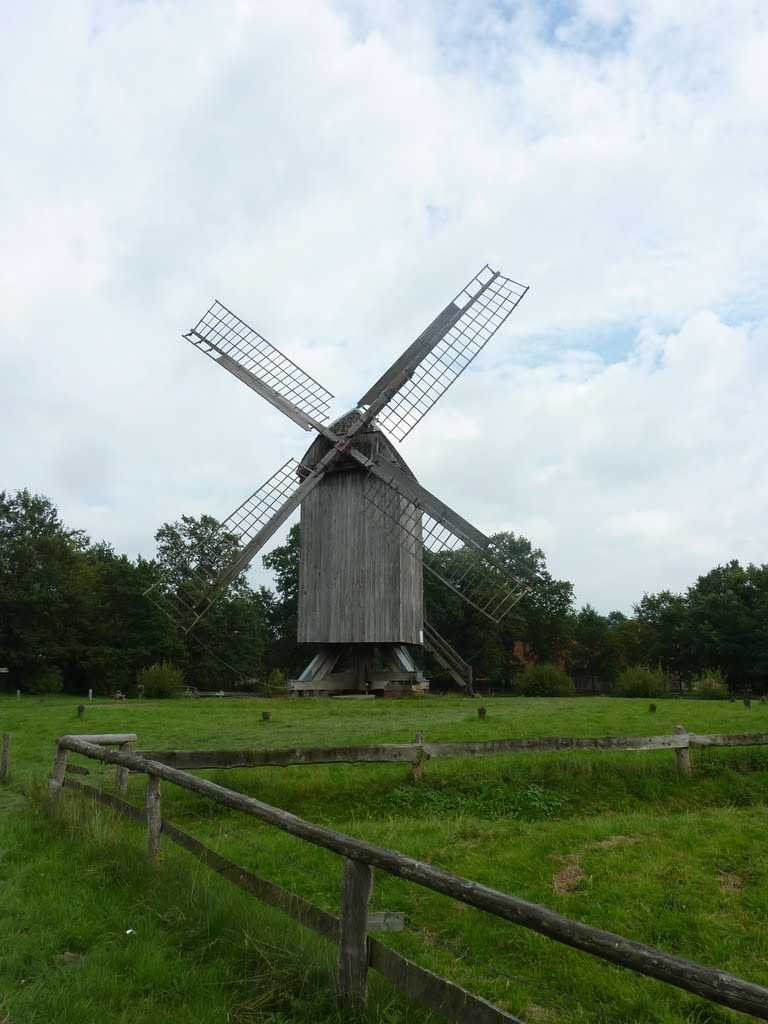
[358,266,527,440]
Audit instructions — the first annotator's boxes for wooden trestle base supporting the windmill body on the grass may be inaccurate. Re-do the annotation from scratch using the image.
[288,643,429,697]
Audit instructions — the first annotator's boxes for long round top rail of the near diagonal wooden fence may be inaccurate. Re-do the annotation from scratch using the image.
[58,736,768,1020]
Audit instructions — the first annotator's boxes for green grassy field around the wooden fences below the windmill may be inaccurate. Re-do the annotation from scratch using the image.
[0,697,768,1024]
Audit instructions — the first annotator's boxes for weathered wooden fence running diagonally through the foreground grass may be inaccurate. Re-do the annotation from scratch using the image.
[50,734,768,1024]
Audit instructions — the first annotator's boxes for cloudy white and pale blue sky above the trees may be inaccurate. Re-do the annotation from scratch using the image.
[0,0,768,613]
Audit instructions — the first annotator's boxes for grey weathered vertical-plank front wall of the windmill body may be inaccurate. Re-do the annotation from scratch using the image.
[298,421,424,644]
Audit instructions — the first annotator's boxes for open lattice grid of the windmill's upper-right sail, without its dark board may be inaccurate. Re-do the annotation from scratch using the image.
[376,265,527,440]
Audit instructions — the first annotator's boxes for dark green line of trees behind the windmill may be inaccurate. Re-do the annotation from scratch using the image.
[0,489,768,693]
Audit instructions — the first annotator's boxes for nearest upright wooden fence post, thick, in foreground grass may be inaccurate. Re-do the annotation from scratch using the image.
[339,858,374,1002]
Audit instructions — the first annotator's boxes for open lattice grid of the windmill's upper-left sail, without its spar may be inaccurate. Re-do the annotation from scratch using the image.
[184,301,333,423]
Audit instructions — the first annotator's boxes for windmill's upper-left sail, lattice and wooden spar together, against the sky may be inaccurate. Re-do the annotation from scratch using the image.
[184,302,333,430]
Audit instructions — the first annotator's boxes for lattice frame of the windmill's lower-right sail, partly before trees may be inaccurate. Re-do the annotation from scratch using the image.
[365,474,531,623]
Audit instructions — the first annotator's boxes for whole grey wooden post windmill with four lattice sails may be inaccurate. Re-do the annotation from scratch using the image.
[147,266,530,694]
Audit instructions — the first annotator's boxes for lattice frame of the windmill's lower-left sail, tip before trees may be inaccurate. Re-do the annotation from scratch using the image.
[146,459,300,632]
